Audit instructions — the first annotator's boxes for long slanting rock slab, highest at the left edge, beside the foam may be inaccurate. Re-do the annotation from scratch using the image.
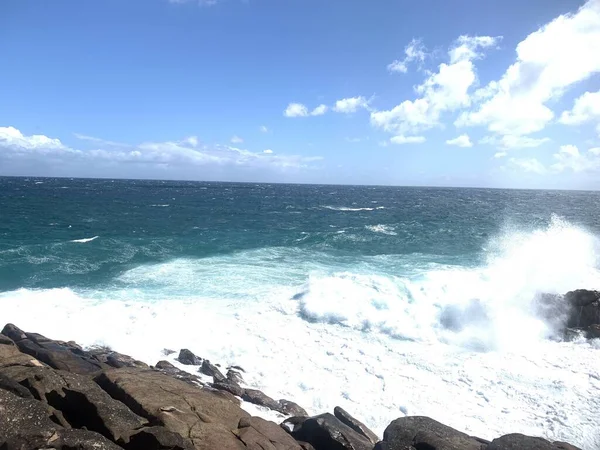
[2,324,108,374]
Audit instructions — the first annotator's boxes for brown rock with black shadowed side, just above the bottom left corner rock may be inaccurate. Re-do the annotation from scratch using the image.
[0,366,148,442]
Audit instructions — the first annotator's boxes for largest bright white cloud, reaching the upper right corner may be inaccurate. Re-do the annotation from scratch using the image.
[455,0,600,135]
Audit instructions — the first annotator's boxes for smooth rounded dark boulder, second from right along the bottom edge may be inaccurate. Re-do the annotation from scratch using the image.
[376,416,488,450]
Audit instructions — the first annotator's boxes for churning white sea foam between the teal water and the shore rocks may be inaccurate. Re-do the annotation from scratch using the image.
[0,218,600,450]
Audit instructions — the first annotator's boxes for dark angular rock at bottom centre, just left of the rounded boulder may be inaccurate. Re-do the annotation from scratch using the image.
[282,413,372,450]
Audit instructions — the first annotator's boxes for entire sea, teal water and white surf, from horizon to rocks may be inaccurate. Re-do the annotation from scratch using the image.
[0,178,600,450]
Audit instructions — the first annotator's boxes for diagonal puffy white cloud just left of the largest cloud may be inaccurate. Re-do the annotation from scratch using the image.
[371,36,501,134]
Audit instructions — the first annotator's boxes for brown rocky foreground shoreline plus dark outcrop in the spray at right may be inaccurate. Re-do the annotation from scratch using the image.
[0,290,600,450]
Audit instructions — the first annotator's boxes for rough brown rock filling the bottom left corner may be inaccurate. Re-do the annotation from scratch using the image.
[0,390,121,450]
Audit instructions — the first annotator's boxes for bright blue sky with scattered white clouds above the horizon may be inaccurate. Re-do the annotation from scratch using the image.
[0,0,600,189]
